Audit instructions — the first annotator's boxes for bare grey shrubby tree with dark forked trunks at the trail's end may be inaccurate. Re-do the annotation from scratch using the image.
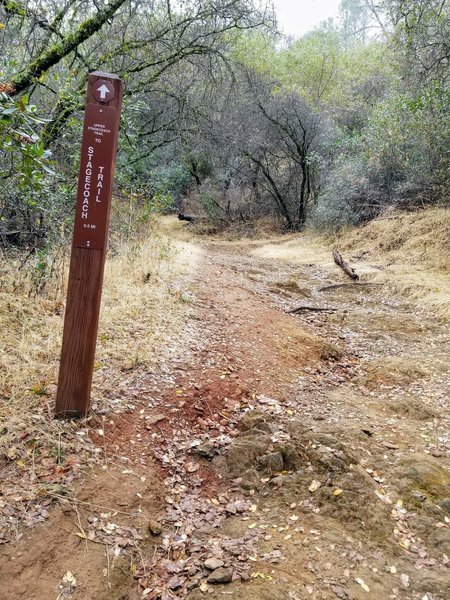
[172,63,325,230]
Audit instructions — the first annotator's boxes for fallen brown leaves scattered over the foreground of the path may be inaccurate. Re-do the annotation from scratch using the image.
[0,234,448,600]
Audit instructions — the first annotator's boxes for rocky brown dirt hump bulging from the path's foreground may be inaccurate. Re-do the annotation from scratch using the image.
[226,411,391,539]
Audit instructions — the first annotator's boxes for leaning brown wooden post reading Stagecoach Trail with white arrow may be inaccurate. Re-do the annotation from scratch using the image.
[55,71,122,418]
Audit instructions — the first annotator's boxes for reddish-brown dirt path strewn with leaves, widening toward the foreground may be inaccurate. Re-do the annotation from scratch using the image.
[0,237,450,600]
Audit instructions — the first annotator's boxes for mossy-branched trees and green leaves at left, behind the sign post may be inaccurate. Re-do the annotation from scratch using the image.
[0,0,270,248]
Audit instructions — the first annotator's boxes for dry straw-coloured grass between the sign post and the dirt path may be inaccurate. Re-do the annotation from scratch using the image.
[93,232,200,409]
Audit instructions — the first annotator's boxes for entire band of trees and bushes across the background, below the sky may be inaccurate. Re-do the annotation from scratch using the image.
[0,0,450,243]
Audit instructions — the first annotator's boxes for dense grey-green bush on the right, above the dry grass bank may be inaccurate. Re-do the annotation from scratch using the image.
[311,86,450,229]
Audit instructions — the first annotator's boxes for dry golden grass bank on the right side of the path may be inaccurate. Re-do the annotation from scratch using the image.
[254,208,450,317]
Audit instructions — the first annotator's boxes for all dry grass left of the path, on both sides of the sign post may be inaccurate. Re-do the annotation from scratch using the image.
[0,220,197,539]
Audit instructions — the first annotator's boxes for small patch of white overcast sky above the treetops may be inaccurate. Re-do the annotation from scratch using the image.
[272,0,340,36]
